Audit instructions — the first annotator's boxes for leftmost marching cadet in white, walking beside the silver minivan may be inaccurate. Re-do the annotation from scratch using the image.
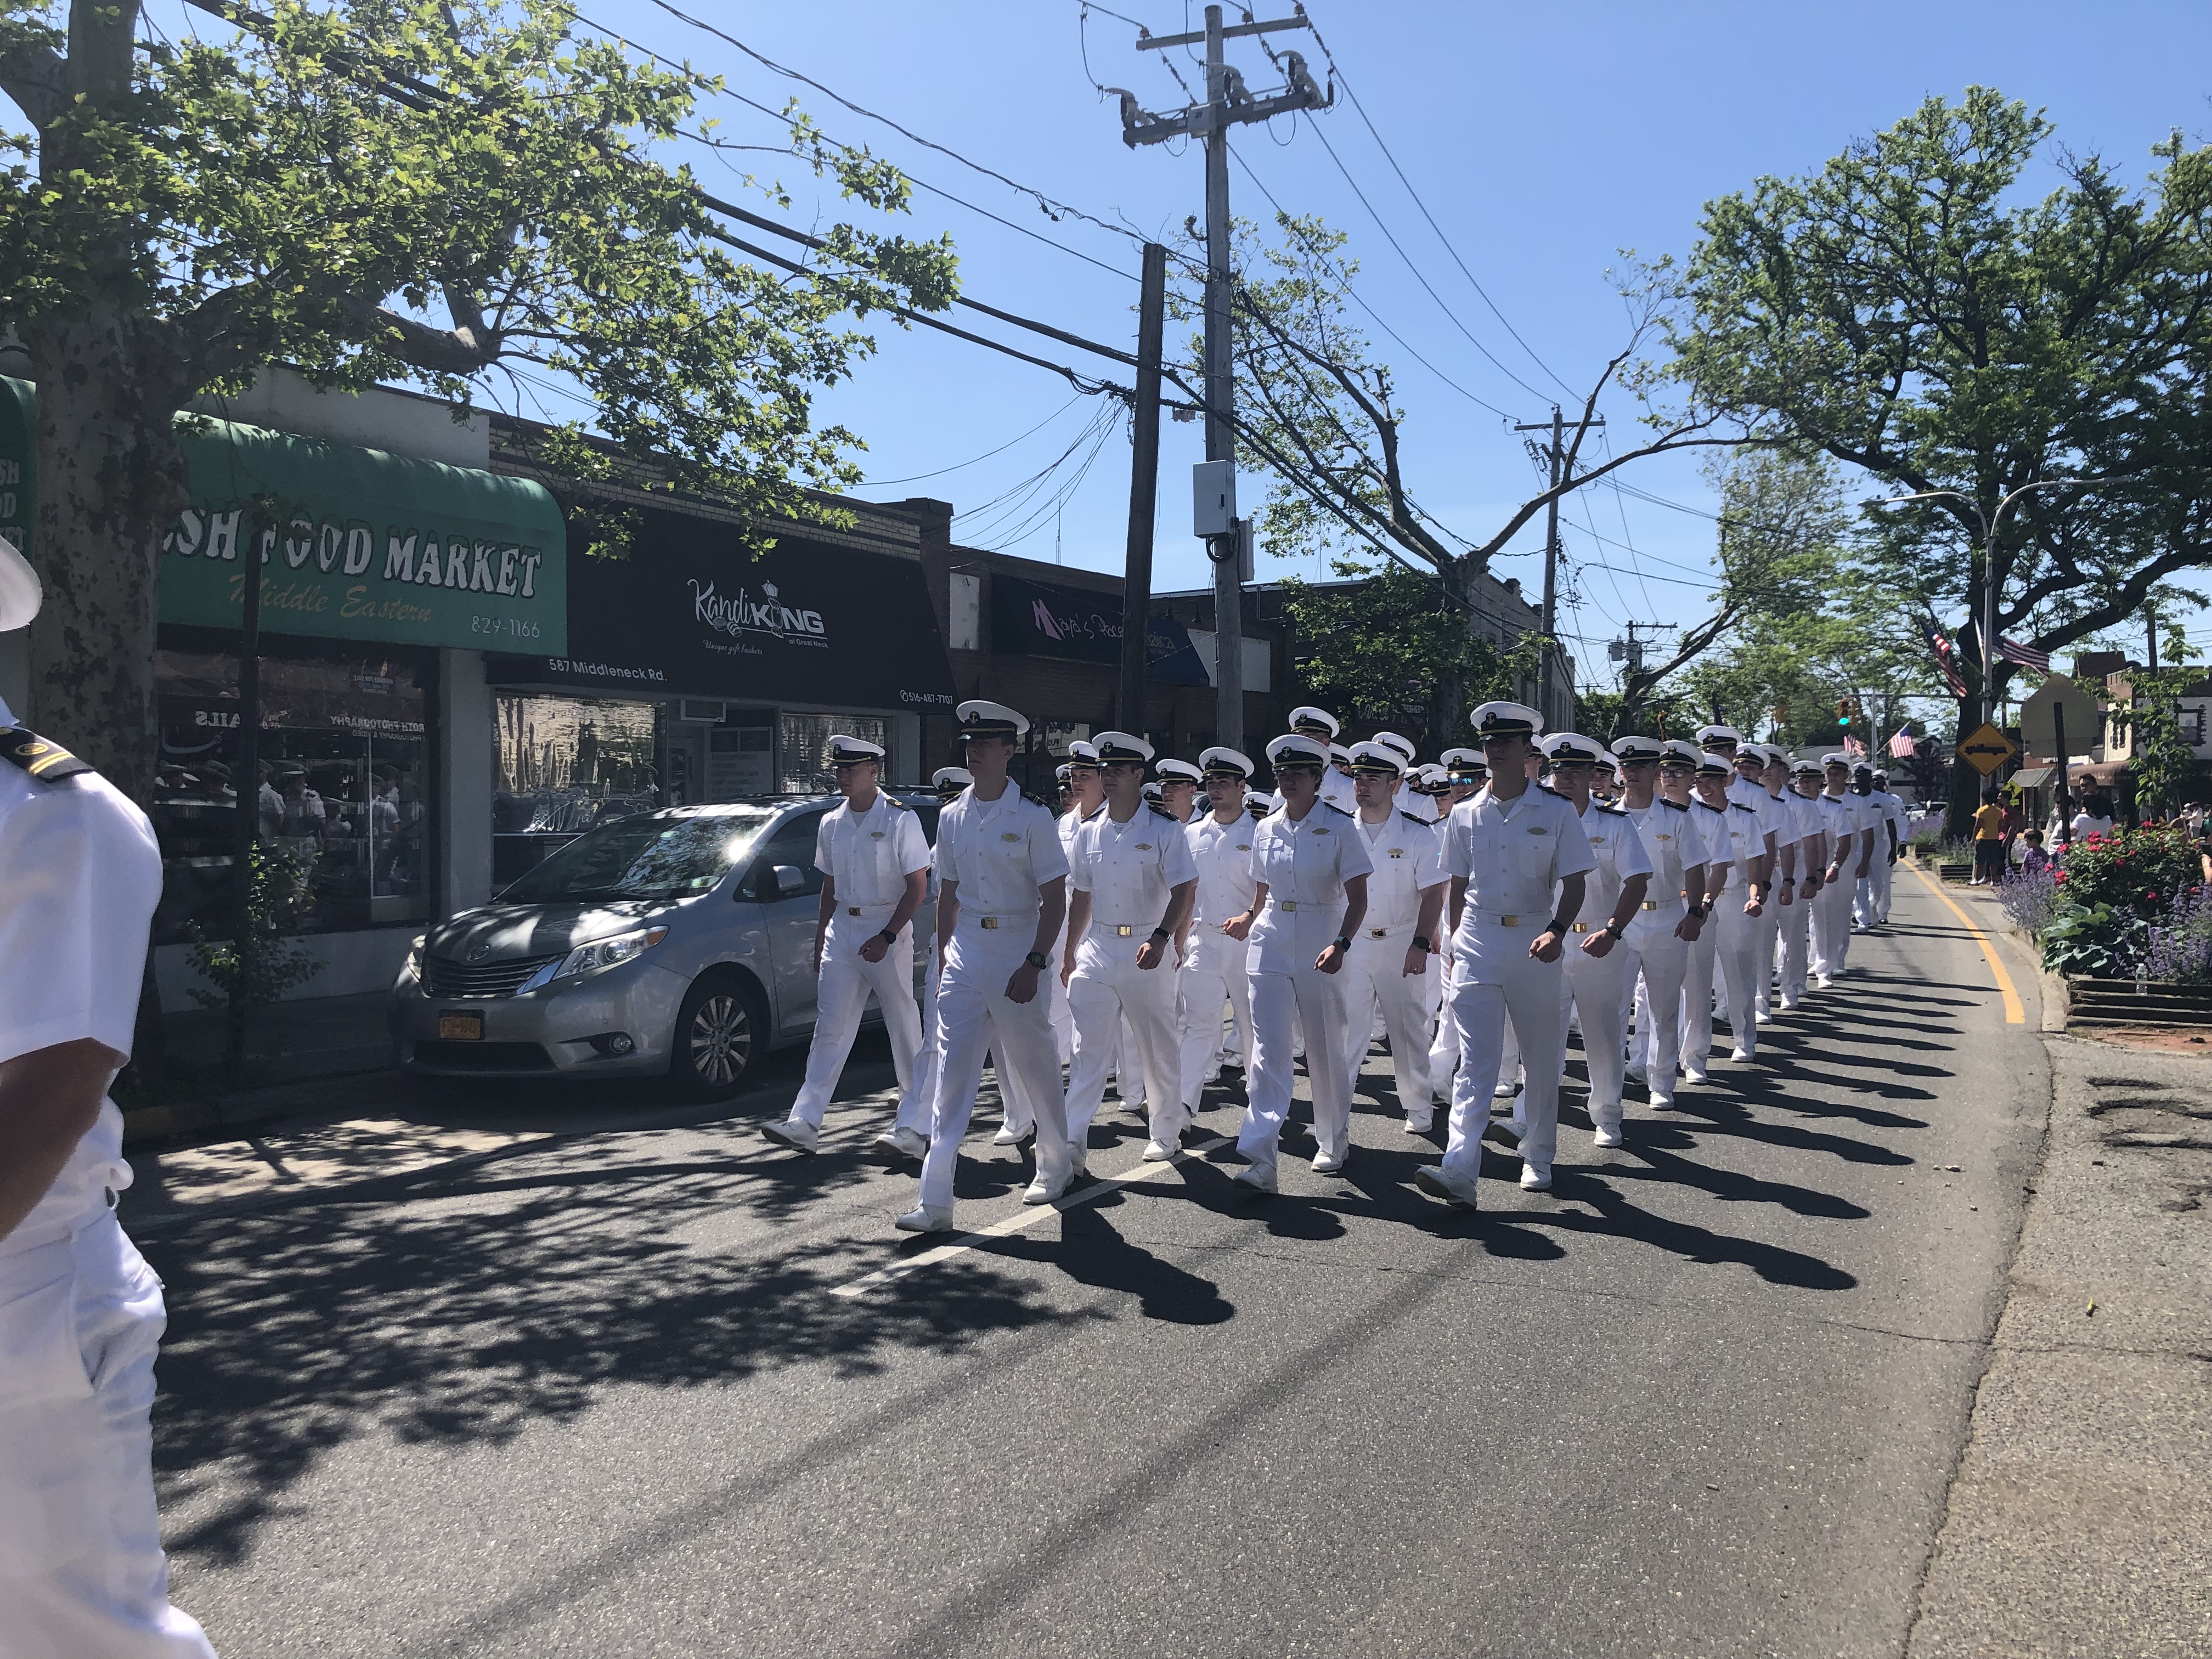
[761,735,929,1157]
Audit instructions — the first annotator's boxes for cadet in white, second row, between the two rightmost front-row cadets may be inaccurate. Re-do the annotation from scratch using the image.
[1345,739,1444,1135]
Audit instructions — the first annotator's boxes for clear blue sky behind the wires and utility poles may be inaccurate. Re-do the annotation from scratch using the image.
[163,0,2212,690]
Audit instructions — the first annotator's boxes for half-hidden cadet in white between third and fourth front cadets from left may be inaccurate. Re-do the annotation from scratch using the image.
[1177,746,1256,1113]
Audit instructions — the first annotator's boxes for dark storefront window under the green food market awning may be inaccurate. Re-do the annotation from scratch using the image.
[153,630,433,943]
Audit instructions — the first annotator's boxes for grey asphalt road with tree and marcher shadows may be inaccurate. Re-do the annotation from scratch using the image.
[148,874,2046,1659]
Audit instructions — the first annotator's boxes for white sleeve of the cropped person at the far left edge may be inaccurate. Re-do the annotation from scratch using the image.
[0,776,161,1062]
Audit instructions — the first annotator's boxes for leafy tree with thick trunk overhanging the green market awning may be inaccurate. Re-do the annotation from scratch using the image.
[0,0,953,794]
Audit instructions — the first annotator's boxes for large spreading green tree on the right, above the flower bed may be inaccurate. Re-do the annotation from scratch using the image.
[1661,86,2212,827]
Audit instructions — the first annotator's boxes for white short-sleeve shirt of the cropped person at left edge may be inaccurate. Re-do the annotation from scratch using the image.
[0,703,161,1254]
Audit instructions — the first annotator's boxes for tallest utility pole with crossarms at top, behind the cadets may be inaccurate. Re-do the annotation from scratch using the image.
[1108,4,1336,750]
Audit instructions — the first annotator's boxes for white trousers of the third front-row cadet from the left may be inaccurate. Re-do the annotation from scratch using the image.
[1066,922,1190,1159]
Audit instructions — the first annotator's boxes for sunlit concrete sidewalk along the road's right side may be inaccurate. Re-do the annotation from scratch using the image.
[1909,885,2212,1659]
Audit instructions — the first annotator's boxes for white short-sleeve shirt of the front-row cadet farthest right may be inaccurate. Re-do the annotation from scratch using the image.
[1444,783,1597,984]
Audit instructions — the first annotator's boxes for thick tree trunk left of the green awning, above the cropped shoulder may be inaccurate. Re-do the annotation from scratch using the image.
[24,305,190,803]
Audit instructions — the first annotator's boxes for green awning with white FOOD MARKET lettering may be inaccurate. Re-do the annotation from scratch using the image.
[0,381,568,657]
